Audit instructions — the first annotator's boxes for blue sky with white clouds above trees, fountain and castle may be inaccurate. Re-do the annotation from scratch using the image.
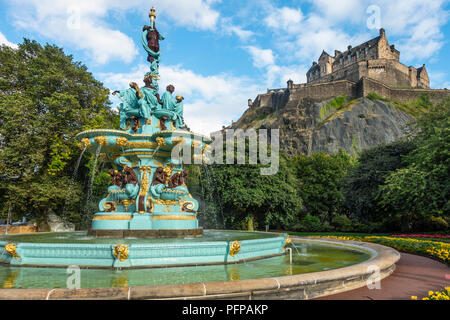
[0,0,450,135]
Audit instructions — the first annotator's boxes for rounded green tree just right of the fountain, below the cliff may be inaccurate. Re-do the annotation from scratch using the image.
[189,155,302,229]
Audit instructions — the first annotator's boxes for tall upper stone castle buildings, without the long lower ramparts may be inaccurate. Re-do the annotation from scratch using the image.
[306,29,430,89]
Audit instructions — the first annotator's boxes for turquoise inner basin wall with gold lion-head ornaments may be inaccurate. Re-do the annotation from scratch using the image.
[0,231,286,268]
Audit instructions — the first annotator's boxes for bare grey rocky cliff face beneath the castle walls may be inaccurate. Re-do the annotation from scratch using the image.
[233,93,415,156]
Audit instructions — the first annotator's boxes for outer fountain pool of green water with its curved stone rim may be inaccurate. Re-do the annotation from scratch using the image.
[0,238,400,300]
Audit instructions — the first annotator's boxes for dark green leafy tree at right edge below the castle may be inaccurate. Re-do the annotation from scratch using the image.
[379,98,450,231]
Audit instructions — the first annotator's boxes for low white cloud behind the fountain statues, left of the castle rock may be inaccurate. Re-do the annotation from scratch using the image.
[98,65,262,135]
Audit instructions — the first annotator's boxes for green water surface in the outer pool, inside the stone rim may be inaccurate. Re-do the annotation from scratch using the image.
[0,241,371,288]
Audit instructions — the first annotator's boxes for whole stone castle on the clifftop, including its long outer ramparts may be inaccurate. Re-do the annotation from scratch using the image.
[244,29,450,114]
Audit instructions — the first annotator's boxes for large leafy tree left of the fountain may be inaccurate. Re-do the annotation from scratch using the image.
[0,39,118,229]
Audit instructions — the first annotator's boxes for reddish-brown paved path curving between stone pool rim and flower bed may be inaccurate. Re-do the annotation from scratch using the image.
[316,253,450,300]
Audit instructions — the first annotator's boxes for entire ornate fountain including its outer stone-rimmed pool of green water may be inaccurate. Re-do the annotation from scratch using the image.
[0,8,399,299]
